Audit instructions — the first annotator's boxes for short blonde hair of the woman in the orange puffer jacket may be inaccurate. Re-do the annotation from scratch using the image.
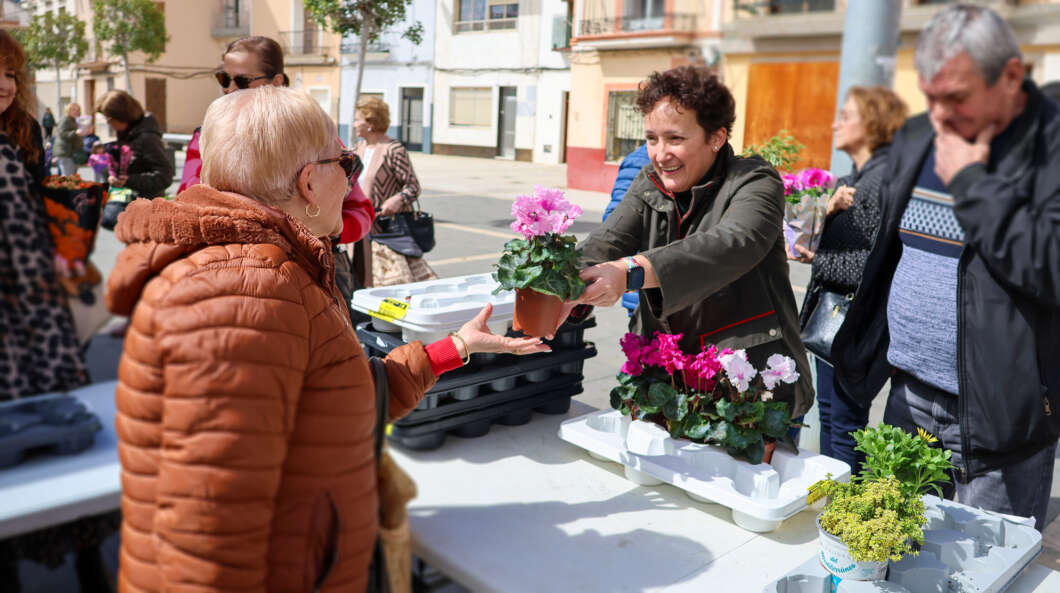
[199,85,336,206]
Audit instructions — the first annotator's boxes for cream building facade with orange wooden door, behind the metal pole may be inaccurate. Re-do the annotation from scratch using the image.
[722,0,1060,169]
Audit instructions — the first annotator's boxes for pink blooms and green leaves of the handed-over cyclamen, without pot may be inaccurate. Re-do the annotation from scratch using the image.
[493,186,585,300]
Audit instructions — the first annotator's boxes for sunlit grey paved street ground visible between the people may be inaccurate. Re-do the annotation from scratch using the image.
[64,153,1060,591]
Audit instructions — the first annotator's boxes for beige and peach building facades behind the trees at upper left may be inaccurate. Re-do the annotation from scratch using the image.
[24,0,340,135]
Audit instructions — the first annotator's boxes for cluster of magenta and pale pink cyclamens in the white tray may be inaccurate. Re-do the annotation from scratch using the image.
[611,332,799,464]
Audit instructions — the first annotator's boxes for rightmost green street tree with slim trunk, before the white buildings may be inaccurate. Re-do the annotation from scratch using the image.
[305,0,423,115]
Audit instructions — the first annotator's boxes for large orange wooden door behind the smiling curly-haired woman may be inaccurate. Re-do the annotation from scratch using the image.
[743,62,840,170]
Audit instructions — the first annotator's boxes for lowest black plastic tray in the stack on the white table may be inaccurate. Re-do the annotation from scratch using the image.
[387,380,582,451]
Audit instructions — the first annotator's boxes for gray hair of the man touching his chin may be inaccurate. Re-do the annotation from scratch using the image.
[915,4,1023,86]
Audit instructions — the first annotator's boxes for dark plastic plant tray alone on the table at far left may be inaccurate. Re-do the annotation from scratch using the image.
[0,396,103,468]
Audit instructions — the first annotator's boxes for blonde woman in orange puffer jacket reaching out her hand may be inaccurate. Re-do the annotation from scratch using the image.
[107,87,548,593]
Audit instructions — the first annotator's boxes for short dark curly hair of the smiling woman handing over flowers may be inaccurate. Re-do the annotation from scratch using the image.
[637,66,736,136]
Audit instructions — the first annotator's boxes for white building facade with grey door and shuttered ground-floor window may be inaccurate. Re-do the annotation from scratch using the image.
[431,0,571,163]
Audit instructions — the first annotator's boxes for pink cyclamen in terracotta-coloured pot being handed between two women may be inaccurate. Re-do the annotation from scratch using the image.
[493,186,585,337]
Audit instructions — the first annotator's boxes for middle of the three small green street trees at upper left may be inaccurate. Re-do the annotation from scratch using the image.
[92,0,170,94]
